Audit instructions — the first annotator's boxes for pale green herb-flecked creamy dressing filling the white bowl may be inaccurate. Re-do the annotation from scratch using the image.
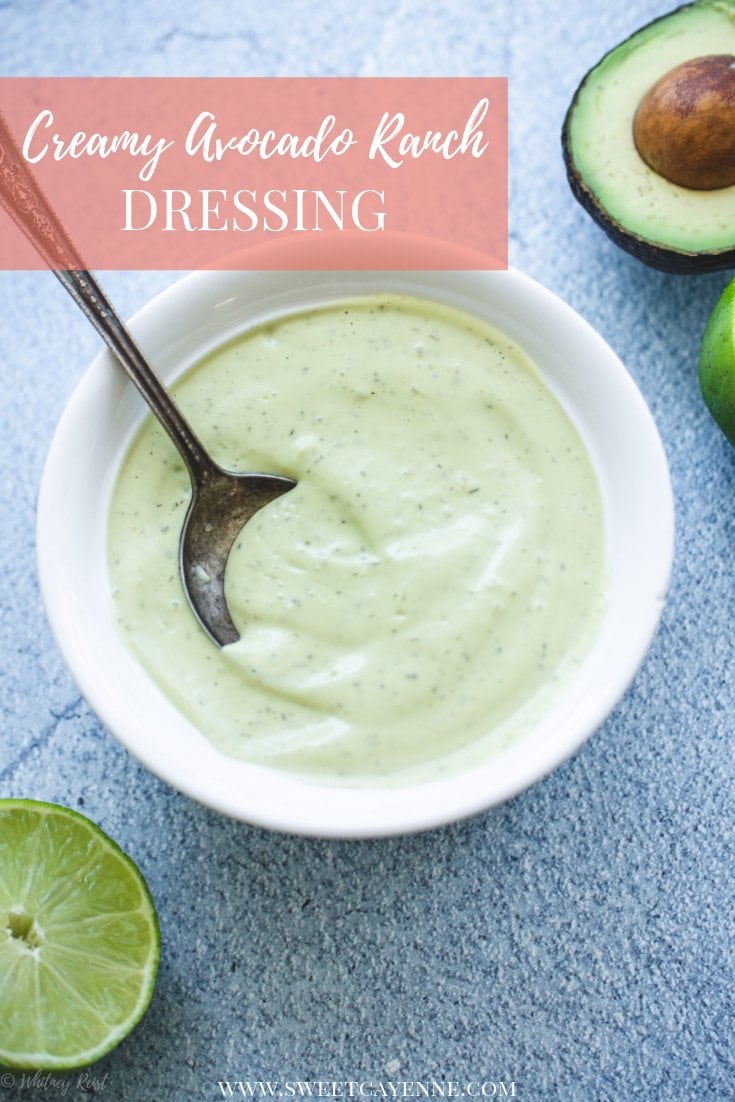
[109,294,605,785]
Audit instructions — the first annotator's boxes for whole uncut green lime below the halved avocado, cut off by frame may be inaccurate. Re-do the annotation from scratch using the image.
[699,279,735,444]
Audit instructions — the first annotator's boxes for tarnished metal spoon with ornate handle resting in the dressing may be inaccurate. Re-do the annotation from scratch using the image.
[0,114,296,647]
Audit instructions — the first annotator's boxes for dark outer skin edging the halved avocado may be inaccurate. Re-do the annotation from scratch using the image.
[562,0,735,276]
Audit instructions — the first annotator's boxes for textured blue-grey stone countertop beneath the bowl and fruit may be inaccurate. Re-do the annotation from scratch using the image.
[0,0,735,1102]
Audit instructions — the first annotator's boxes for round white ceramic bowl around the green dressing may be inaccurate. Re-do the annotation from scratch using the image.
[37,270,673,838]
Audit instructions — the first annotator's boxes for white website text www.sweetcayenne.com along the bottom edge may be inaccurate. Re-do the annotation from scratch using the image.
[217,1079,520,1102]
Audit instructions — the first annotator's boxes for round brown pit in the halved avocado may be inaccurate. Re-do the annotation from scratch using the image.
[633,54,735,191]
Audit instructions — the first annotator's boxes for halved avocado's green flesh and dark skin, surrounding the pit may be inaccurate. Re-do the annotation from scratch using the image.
[562,0,735,273]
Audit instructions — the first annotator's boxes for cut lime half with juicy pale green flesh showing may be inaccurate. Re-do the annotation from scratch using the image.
[0,800,161,1071]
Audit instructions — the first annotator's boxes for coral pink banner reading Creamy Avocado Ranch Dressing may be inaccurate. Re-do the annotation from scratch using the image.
[0,77,508,270]
